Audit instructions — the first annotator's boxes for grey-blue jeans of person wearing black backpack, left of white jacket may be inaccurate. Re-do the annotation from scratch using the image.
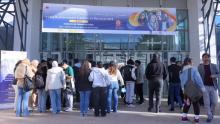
[37,89,47,112]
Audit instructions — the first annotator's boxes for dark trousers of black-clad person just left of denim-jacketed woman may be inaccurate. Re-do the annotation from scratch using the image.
[169,83,182,109]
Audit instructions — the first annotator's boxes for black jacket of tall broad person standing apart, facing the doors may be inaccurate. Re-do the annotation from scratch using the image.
[145,60,167,80]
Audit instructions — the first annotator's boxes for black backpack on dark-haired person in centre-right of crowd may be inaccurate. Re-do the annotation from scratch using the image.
[122,65,135,81]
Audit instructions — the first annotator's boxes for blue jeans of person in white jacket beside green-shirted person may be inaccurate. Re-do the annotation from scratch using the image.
[49,89,61,114]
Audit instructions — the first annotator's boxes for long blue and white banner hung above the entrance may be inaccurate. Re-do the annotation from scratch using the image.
[42,3,177,35]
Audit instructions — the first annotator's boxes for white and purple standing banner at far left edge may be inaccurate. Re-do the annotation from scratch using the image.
[0,51,27,109]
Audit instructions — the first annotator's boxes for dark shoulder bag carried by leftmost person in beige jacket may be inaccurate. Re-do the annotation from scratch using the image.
[23,66,34,92]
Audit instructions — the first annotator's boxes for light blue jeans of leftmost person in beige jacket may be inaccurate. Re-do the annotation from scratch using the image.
[16,88,30,117]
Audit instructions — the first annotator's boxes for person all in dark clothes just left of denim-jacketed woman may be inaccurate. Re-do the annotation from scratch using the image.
[168,57,182,111]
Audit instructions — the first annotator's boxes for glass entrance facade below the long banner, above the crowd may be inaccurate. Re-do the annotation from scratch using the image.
[40,10,189,65]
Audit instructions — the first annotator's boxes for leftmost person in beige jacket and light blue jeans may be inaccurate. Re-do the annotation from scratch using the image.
[15,59,34,117]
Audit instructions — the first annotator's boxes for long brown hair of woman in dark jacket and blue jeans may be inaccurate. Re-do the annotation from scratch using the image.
[79,60,91,76]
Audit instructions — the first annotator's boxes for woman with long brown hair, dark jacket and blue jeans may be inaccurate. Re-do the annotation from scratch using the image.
[77,60,92,117]
